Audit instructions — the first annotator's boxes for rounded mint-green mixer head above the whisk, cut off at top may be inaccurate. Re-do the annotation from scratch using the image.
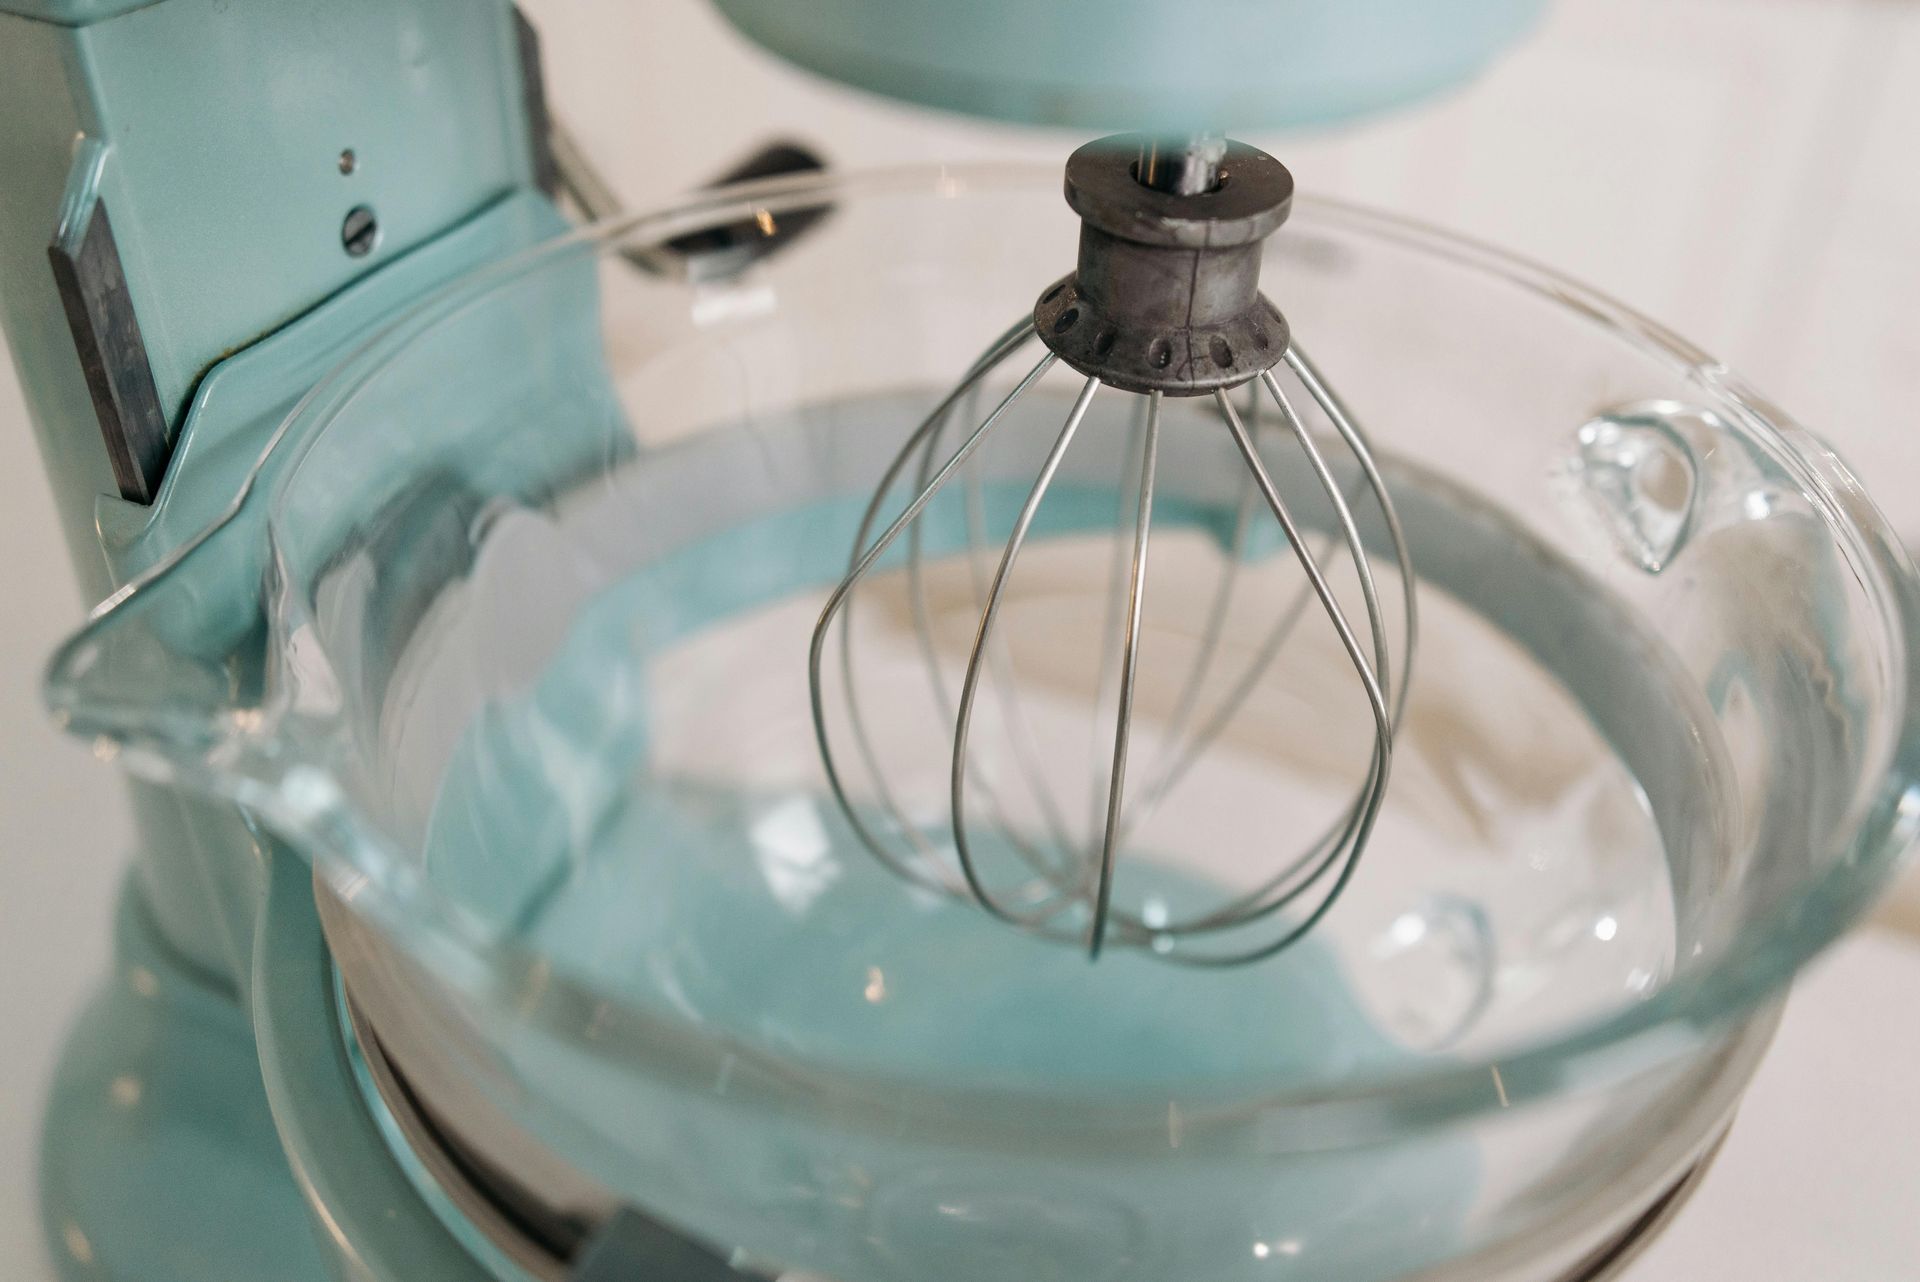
[714,0,1546,131]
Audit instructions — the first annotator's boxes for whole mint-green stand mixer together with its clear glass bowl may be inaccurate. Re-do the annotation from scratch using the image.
[0,0,1920,1282]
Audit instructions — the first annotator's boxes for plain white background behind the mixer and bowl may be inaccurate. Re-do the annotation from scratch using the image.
[0,0,1920,1282]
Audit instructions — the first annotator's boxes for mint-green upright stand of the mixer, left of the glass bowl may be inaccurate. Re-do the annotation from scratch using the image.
[0,0,564,1282]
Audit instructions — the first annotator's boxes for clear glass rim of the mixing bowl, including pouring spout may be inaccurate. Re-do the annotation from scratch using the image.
[46,163,1920,1146]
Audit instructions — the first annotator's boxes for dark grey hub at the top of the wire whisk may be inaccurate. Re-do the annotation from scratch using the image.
[1033,134,1294,395]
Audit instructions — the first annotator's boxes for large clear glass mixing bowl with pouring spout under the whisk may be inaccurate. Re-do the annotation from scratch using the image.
[50,169,1920,1282]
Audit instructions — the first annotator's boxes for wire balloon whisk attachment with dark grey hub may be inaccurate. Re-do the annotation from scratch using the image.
[808,134,1415,965]
